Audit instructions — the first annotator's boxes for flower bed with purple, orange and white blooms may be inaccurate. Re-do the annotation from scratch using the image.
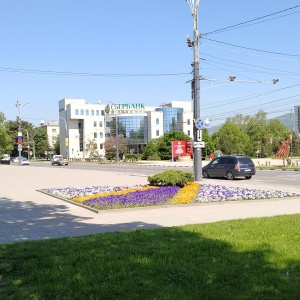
[40,182,300,210]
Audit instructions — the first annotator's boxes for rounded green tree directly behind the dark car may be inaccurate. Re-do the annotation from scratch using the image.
[213,123,249,155]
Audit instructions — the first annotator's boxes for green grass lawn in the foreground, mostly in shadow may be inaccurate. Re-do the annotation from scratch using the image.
[0,214,300,300]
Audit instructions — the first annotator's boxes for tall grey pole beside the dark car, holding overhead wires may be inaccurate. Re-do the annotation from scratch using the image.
[186,0,202,181]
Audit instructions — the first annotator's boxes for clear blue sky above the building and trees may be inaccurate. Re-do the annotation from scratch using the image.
[0,0,300,126]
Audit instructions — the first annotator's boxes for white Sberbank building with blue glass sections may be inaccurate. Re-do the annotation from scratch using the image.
[59,98,193,159]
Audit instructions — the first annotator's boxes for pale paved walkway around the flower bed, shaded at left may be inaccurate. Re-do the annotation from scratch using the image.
[0,162,300,244]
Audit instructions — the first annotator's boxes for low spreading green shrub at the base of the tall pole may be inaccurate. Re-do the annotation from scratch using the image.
[148,170,194,187]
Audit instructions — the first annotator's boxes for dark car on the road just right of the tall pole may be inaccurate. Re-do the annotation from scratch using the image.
[202,155,255,180]
